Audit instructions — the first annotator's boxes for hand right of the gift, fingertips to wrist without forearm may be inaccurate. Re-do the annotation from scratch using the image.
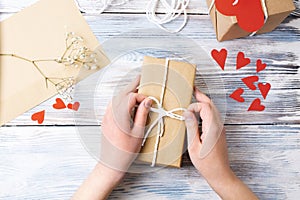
[184,88,231,185]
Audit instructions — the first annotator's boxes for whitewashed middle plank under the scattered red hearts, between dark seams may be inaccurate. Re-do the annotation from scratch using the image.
[1,14,300,125]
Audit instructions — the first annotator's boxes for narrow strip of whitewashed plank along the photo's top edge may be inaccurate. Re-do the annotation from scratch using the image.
[0,0,208,15]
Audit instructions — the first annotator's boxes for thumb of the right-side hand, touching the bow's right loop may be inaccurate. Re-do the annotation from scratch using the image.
[184,111,202,152]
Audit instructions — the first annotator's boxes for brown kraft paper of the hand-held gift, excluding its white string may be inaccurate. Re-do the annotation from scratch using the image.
[138,57,196,167]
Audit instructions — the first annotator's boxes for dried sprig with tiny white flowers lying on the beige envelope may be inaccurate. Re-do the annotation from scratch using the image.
[0,32,99,101]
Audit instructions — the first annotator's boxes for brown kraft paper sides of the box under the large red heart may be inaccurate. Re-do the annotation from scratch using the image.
[206,0,295,41]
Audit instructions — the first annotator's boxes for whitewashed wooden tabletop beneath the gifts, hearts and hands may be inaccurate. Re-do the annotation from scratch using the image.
[0,0,300,200]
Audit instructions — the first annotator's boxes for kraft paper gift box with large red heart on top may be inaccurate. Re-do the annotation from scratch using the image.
[206,0,295,41]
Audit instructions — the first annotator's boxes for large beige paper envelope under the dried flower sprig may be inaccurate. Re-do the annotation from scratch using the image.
[0,0,109,125]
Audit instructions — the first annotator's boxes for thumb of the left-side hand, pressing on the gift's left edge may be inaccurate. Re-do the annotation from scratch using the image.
[132,98,152,138]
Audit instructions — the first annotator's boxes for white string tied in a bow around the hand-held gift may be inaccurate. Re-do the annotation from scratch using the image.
[142,58,186,167]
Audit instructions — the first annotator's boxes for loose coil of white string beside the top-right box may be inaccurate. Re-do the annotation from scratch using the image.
[146,0,190,33]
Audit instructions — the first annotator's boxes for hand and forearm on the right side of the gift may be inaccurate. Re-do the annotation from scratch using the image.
[184,88,257,199]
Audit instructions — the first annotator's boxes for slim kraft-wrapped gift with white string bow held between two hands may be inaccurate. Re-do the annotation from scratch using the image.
[137,57,196,167]
